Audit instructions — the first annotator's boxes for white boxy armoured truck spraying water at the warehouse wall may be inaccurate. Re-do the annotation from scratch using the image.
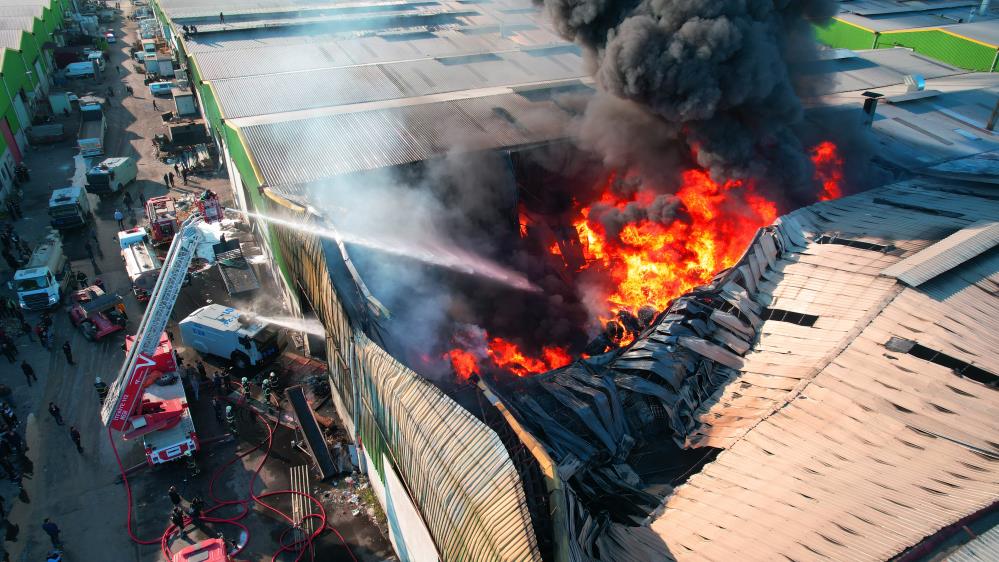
[180,304,284,370]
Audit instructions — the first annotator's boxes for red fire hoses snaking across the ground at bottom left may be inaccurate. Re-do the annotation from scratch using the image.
[108,402,357,562]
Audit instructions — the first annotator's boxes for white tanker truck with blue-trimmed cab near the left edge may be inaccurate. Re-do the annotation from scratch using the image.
[14,230,69,310]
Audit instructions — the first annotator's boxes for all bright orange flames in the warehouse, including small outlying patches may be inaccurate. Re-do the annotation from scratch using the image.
[445,141,843,380]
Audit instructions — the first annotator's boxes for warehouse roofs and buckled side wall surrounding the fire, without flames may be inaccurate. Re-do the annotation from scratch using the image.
[148,0,999,560]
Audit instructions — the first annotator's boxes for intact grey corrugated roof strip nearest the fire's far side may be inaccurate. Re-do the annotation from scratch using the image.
[243,89,568,190]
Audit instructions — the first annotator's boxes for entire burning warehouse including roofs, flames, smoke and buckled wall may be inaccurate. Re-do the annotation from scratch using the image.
[159,0,999,560]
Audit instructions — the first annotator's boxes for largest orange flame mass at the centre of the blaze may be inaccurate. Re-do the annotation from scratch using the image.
[574,166,777,313]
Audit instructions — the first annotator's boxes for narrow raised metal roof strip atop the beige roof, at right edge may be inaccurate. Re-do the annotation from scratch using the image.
[881,220,999,287]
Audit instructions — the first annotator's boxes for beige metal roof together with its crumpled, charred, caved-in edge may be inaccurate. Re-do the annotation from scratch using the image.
[492,164,999,560]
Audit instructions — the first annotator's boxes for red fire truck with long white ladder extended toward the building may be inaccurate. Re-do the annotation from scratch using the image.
[101,191,223,464]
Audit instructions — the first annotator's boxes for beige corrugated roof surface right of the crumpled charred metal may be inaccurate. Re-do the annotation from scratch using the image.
[651,173,999,560]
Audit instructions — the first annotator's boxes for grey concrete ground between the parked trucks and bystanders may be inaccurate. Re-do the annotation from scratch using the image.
[0,5,393,561]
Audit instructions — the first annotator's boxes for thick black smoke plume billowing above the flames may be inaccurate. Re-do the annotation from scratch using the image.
[543,0,835,198]
